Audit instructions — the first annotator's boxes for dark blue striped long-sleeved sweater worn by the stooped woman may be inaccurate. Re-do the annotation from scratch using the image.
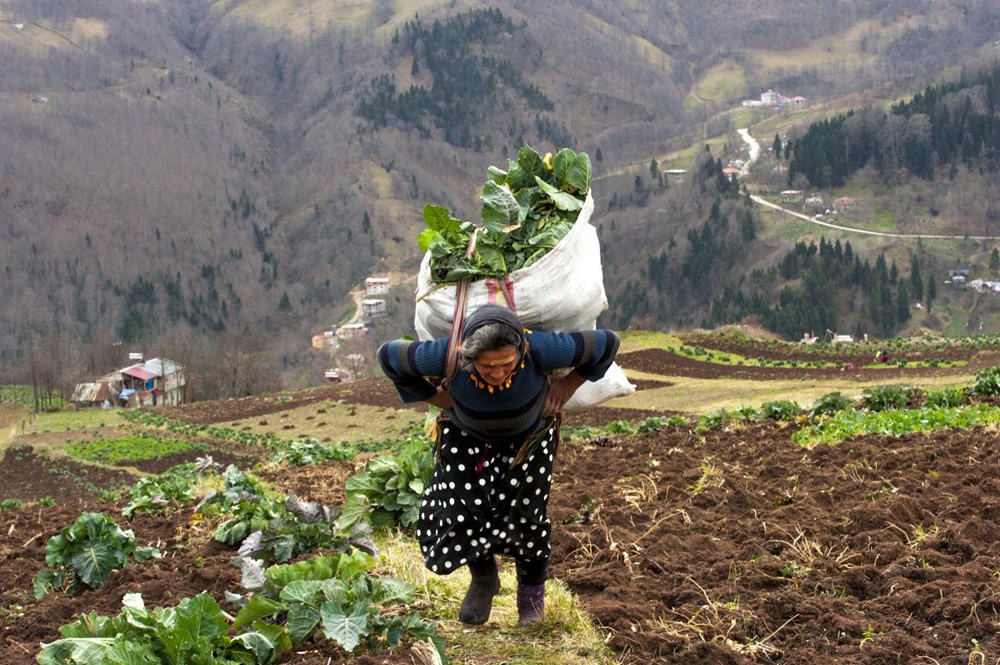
[378,329,619,443]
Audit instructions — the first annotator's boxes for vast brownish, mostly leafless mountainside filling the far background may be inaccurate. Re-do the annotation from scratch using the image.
[0,0,998,393]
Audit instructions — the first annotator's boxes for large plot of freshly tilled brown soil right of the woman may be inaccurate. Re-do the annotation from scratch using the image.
[551,425,1000,664]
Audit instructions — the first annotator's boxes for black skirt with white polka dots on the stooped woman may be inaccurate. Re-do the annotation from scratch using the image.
[417,423,558,575]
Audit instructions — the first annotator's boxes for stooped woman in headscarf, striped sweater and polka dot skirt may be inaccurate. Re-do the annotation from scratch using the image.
[378,305,618,626]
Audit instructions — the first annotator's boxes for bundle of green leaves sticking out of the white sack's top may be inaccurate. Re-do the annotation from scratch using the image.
[419,146,590,284]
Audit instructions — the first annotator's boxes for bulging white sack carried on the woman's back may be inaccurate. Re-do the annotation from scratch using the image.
[414,192,635,409]
